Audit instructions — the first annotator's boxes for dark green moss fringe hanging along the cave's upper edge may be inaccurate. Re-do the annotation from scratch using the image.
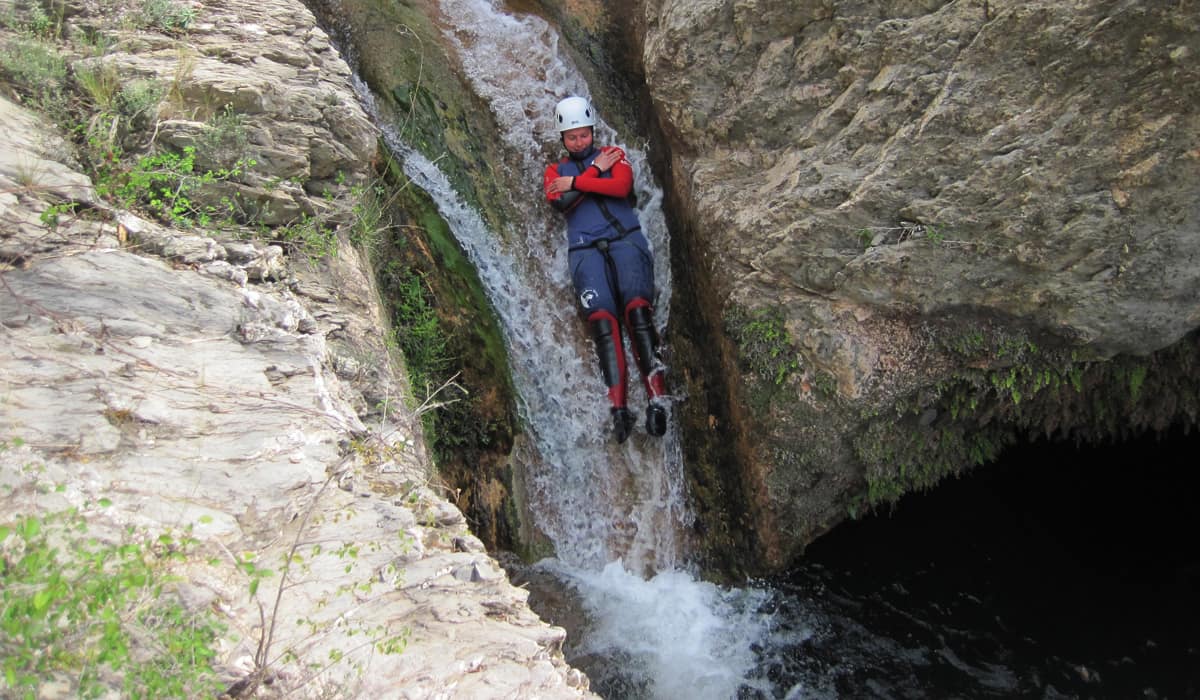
[848,328,1200,516]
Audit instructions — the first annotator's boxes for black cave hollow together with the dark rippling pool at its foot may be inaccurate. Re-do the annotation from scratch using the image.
[745,427,1200,699]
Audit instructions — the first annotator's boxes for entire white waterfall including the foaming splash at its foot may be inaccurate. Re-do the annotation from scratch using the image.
[350,0,770,699]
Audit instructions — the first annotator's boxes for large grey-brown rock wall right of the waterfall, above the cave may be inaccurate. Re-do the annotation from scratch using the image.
[640,0,1200,564]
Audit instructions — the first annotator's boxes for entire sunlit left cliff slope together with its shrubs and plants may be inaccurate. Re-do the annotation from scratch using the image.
[0,1,586,698]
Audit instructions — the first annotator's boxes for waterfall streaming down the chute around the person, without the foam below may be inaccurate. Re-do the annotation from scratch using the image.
[436,0,691,573]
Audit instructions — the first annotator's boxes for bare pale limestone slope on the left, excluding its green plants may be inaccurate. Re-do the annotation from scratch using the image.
[0,0,592,698]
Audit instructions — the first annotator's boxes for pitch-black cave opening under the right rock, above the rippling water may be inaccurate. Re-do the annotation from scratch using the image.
[804,430,1200,698]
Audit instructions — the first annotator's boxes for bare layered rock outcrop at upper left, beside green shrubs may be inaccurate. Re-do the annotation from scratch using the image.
[74,1,378,218]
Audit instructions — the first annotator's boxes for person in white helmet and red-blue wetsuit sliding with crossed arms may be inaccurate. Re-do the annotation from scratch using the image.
[542,97,667,443]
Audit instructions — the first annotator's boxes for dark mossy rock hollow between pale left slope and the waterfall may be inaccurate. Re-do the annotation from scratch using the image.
[377,153,521,550]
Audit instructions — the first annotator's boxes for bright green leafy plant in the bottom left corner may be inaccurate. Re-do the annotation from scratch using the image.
[0,499,223,699]
